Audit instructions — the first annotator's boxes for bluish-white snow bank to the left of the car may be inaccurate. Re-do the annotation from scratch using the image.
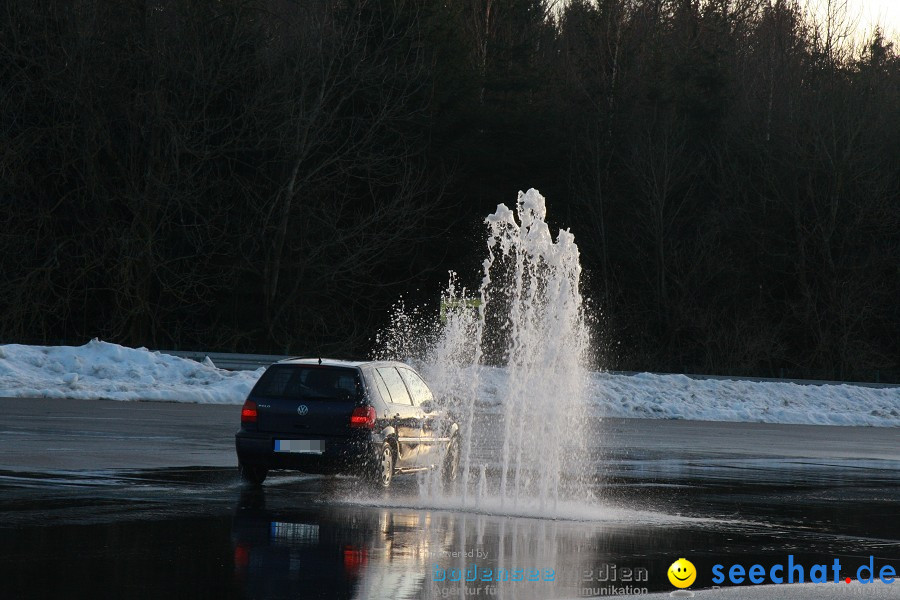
[0,339,263,404]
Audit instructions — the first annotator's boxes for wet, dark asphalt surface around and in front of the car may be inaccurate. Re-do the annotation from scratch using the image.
[0,399,900,599]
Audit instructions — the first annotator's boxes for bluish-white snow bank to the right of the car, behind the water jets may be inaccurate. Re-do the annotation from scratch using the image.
[464,369,900,427]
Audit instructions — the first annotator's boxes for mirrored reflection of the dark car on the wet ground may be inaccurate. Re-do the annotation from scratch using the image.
[231,490,453,599]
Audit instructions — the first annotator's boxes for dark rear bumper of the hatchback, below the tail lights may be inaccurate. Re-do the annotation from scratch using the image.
[234,431,381,473]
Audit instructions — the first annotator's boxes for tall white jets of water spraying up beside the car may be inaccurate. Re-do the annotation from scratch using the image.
[378,189,590,510]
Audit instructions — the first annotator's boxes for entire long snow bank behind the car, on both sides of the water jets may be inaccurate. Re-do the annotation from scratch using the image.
[0,340,900,427]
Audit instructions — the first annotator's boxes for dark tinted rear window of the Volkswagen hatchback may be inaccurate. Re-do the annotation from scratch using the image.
[252,365,362,400]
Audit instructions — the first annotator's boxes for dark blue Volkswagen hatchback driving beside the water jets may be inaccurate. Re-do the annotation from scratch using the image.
[235,359,460,487]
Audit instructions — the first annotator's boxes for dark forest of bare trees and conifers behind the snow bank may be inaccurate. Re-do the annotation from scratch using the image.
[0,0,900,379]
